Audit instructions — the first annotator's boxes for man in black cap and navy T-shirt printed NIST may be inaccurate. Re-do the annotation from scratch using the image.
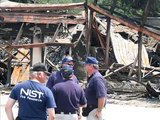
[5,63,56,120]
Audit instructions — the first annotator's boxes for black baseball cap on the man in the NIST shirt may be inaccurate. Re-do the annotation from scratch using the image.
[30,63,51,75]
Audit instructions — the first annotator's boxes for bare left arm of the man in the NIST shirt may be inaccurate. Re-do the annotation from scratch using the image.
[5,98,16,120]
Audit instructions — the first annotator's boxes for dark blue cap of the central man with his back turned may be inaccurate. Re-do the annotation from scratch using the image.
[61,65,74,78]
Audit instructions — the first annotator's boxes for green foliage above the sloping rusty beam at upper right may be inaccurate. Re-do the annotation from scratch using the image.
[98,0,160,17]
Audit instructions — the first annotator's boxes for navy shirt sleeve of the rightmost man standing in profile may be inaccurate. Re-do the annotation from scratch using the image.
[94,77,107,98]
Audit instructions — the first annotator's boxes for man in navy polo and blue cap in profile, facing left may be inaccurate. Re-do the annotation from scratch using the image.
[83,57,107,120]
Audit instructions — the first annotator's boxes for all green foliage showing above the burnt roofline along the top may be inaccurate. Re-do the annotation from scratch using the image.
[7,0,160,17]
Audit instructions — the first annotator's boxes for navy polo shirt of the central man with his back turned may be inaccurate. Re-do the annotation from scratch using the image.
[51,80,87,113]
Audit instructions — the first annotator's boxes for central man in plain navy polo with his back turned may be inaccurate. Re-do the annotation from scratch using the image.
[51,65,86,120]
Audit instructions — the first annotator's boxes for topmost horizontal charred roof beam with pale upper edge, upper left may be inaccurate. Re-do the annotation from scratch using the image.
[0,2,84,11]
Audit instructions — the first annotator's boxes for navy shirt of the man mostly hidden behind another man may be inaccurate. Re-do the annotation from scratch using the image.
[46,71,79,89]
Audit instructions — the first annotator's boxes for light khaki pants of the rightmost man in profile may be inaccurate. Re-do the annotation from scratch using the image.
[87,108,106,120]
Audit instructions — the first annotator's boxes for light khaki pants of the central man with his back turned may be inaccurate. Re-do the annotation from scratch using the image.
[56,113,78,120]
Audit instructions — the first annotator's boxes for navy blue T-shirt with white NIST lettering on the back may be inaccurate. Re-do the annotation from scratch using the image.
[10,80,56,120]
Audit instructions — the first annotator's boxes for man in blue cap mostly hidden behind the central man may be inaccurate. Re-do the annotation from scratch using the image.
[46,56,78,89]
